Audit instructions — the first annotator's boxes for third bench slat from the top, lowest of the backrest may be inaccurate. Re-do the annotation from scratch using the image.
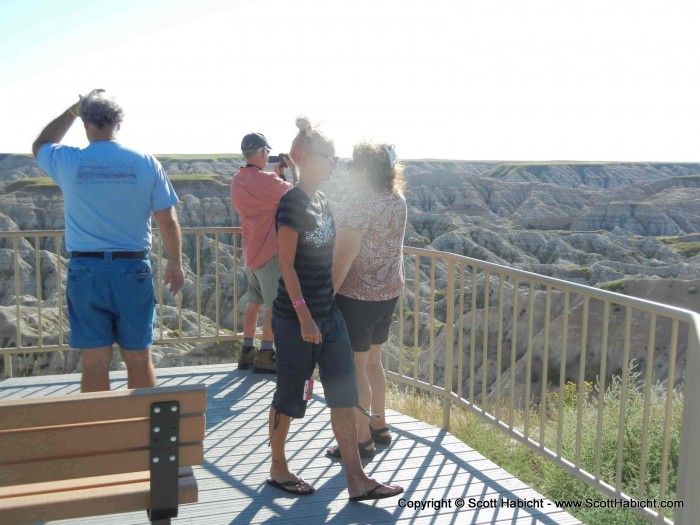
[0,443,204,486]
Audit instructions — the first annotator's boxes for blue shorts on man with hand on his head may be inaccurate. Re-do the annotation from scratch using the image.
[66,257,156,350]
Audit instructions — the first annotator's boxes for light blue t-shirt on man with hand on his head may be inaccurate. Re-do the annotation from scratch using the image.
[37,141,179,252]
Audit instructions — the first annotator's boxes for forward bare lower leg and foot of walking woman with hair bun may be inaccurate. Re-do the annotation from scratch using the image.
[331,408,403,498]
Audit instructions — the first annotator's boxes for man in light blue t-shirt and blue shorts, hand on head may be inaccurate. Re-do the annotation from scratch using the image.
[32,89,184,392]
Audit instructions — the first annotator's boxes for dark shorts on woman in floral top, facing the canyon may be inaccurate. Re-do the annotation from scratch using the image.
[335,294,399,352]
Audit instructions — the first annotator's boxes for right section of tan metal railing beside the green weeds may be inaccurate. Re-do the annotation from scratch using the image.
[392,248,700,524]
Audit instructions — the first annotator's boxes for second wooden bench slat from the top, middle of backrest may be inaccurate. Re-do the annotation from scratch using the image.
[0,414,206,462]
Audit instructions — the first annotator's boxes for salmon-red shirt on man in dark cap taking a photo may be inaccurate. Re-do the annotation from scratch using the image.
[231,166,293,270]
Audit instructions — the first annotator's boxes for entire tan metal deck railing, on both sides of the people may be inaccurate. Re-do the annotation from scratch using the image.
[0,228,700,525]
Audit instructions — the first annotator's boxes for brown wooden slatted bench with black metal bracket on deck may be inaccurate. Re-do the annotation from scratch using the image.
[0,384,207,525]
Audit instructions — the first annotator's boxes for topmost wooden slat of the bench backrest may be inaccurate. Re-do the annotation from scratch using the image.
[0,384,207,431]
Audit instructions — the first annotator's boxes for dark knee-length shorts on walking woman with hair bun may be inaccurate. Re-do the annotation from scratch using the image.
[272,310,359,418]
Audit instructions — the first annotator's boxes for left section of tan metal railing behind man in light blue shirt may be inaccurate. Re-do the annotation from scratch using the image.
[0,227,242,377]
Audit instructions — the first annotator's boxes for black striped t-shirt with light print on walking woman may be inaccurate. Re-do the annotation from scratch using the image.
[272,186,335,319]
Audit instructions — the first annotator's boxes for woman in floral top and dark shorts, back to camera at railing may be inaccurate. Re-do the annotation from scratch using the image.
[333,143,406,457]
